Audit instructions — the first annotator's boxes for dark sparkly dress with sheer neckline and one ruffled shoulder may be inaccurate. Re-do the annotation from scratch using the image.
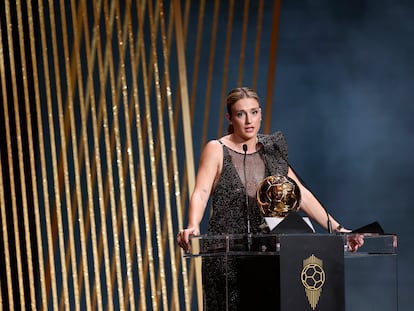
[202,132,288,311]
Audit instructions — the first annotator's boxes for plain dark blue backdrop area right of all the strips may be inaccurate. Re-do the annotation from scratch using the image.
[272,0,414,310]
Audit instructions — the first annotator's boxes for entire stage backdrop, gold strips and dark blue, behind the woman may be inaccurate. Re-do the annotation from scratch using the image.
[0,0,414,311]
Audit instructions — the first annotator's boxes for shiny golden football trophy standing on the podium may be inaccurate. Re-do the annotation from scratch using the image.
[256,175,301,217]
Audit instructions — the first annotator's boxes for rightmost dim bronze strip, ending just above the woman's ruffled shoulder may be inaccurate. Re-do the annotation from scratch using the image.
[263,0,281,133]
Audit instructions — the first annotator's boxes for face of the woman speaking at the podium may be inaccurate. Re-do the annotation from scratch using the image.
[227,98,262,139]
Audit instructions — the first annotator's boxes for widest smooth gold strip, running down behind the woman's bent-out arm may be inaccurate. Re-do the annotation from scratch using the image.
[173,0,196,308]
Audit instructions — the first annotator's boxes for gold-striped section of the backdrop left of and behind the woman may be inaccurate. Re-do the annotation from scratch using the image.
[0,0,280,311]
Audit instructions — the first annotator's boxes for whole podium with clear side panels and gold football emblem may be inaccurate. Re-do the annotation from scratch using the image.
[185,233,398,311]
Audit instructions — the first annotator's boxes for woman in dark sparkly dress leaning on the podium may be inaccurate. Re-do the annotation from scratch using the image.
[177,87,358,310]
